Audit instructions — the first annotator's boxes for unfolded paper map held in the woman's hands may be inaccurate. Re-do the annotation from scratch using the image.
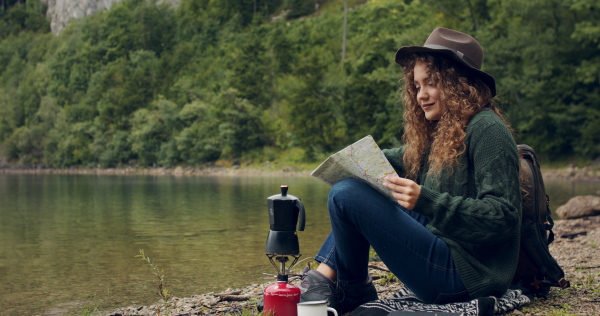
[310,135,396,201]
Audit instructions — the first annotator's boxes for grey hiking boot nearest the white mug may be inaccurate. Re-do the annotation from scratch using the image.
[299,270,337,310]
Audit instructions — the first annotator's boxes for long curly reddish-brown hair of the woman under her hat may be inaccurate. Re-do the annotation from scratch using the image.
[400,54,510,180]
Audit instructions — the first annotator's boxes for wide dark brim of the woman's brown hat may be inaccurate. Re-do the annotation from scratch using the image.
[395,46,496,97]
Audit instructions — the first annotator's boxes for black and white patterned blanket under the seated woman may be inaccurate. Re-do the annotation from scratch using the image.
[352,287,533,316]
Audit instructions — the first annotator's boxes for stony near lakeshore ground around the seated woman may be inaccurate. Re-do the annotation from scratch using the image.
[101,216,600,316]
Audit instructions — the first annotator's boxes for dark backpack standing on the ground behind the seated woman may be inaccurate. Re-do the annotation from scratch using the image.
[512,145,570,297]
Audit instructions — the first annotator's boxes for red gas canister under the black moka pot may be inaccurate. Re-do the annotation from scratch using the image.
[264,275,300,316]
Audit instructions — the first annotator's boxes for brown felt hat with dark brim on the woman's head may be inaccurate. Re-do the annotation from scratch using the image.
[396,27,496,96]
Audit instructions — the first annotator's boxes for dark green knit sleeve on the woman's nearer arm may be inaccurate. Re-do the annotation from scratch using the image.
[414,114,521,244]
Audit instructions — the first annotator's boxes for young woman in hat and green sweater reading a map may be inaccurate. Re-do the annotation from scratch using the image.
[300,28,521,313]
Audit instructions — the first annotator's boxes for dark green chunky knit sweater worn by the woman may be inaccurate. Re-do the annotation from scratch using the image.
[384,109,521,298]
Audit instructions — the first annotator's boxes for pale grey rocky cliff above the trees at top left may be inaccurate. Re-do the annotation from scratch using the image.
[42,0,180,35]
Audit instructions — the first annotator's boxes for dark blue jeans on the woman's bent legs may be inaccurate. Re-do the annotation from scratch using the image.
[315,179,470,304]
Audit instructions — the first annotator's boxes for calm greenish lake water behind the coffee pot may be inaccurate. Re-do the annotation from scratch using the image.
[0,174,600,315]
